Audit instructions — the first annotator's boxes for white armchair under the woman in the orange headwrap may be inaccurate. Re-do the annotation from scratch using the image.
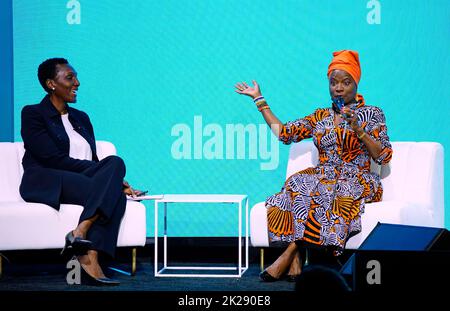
[250,141,444,267]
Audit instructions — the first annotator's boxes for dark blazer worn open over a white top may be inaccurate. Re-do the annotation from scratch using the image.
[20,95,98,210]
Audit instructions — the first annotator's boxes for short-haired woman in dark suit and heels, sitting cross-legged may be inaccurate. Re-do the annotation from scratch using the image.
[20,58,136,285]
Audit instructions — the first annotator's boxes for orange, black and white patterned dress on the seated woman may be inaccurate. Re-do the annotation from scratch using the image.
[266,94,392,254]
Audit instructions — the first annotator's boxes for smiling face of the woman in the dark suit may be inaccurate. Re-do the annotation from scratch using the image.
[47,64,80,103]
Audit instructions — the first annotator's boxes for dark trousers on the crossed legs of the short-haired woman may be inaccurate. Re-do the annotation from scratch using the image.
[61,156,127,257]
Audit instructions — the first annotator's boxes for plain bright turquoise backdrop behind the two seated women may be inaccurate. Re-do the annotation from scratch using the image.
[13,0,450,236]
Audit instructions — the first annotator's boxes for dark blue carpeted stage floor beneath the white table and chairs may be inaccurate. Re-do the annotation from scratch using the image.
[0,259,294,292]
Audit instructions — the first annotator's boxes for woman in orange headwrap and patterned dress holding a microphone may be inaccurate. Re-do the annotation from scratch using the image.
[236,50,392,282]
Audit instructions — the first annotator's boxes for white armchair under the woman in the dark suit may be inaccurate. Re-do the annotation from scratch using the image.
[0,141,146,276]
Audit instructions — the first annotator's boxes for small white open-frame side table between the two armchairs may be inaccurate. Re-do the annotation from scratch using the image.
[155,194,248,278]
